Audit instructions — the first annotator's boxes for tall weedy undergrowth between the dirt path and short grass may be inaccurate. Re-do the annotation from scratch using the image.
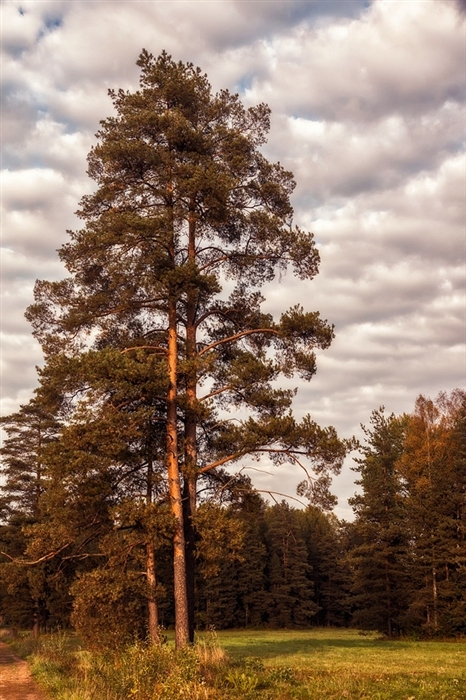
[30,633,296,700]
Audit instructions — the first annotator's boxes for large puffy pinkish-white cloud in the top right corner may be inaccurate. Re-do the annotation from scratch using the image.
[244,2,465,123]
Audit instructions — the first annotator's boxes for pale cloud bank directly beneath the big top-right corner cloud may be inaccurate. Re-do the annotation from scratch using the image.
[269,106,464,206]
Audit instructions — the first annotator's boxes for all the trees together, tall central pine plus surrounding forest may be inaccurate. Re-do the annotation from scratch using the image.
[0,51,466,647]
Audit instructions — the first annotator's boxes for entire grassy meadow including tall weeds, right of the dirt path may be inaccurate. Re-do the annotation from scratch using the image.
[4,628,466,700]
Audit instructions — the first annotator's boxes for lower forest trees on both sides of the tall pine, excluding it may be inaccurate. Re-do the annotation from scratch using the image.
[0,390,466,645]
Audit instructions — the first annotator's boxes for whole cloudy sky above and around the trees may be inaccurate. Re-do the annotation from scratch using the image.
[1,0,466,517]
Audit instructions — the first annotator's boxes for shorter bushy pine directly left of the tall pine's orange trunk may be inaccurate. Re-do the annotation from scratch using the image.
[31,349,170,642]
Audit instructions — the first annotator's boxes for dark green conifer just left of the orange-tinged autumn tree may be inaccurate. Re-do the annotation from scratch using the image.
[349,408,408,637]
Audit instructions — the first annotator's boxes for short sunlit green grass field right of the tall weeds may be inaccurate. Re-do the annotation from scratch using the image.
[210,629,466,700]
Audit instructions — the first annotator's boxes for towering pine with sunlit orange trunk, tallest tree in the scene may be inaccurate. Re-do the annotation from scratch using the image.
[28,51,345,646]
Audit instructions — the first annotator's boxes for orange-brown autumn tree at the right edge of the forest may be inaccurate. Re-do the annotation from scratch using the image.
[398,390,466,634]
